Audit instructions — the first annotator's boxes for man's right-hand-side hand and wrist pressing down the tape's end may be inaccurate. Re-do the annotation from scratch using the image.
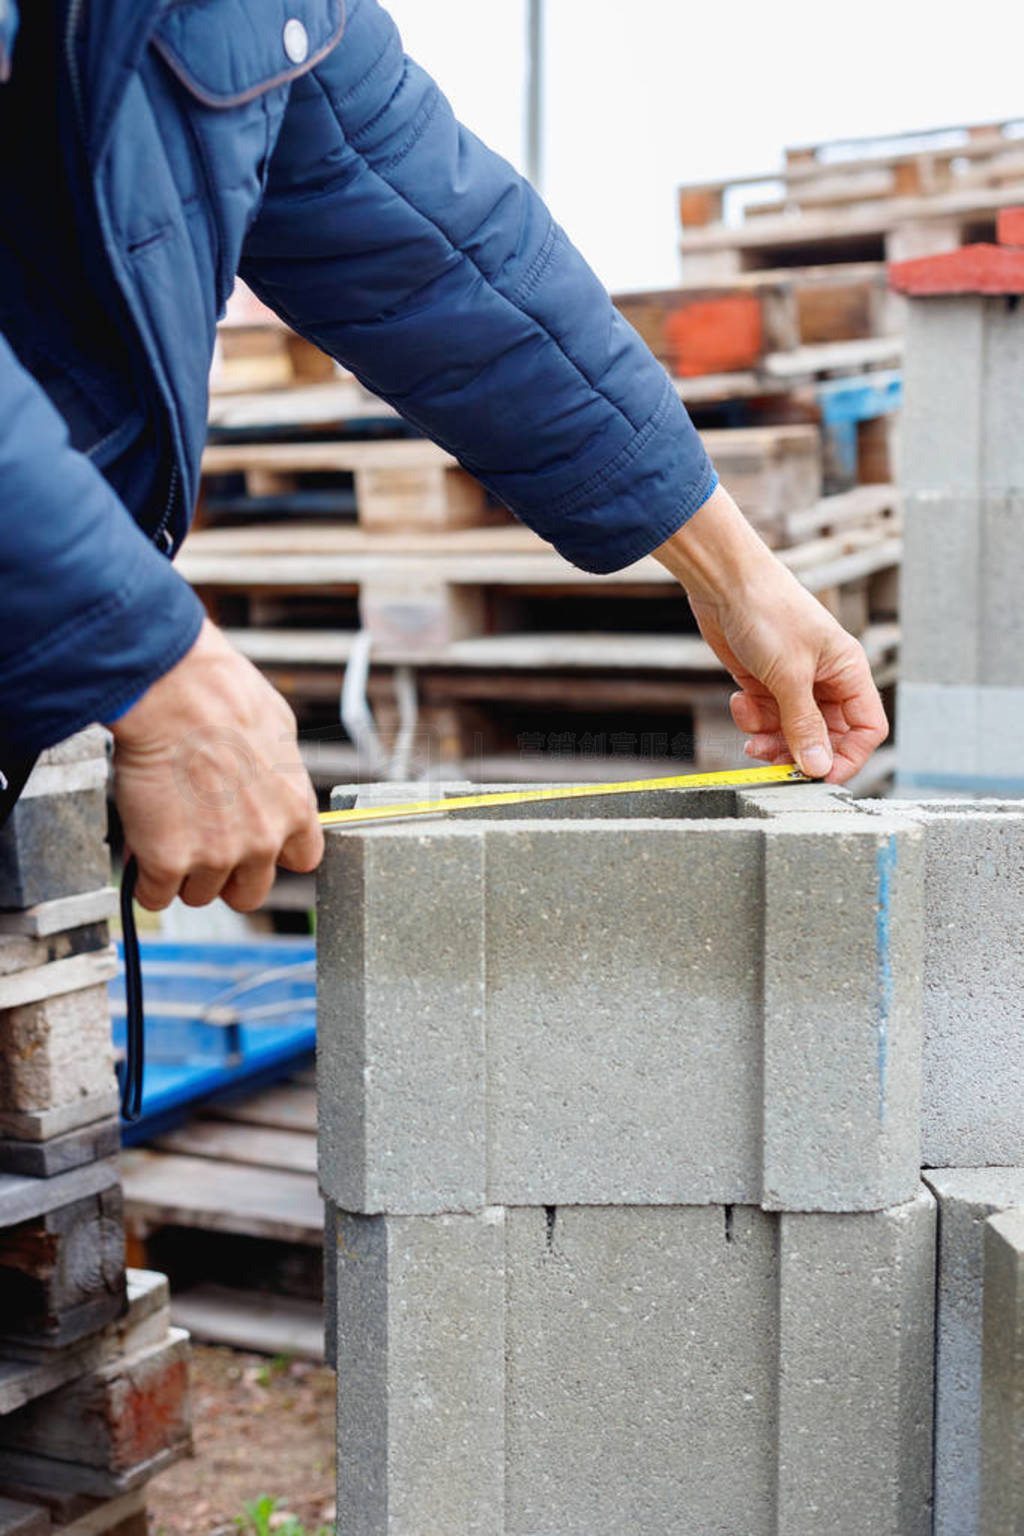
[654,487,889,783]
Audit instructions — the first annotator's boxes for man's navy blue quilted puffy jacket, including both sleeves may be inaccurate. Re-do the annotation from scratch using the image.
[0,0,715,753]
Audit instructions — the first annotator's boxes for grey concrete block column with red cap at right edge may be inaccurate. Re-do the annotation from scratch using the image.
[890,213,1024,794]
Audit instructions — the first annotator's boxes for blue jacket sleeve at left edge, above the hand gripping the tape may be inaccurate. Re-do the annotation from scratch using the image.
[0,335,203,755]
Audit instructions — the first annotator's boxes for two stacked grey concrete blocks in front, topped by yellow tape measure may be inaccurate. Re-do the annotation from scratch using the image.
[318,786,935,1536]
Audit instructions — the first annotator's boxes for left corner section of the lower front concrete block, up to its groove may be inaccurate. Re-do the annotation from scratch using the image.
[336,1210,505,1536]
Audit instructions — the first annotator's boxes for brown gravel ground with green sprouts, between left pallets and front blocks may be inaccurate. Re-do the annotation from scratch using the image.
[149,1344,335,1536]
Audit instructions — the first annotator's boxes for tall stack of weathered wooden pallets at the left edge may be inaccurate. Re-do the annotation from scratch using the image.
[0,731,189,1536]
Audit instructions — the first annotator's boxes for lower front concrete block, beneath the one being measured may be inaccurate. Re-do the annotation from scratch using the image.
[338,1195,933,1536]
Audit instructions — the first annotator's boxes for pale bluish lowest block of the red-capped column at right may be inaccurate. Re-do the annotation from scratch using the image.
[897,682,1024,796]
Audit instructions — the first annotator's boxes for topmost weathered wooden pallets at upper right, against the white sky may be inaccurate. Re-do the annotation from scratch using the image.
[679,121,1024,283]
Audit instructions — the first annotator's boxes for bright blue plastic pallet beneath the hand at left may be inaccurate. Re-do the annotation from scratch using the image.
[109,938,316,1146]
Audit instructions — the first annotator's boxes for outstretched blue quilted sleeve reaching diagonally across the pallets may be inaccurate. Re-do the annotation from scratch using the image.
[241,0,717,571]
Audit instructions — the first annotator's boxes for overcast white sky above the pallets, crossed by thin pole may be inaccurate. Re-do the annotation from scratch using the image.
[385,0,1024,289]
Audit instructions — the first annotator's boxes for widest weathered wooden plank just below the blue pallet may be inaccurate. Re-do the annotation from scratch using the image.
[121,1152,324,1246]
